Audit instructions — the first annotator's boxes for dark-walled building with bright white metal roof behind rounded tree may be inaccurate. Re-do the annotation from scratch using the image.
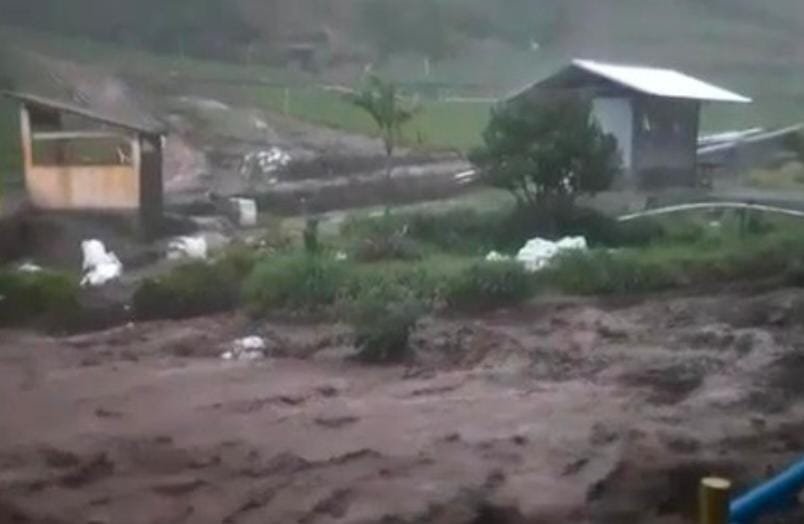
[509,60,751,188]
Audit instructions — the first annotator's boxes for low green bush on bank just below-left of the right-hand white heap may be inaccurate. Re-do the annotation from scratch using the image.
[444,261,534,310]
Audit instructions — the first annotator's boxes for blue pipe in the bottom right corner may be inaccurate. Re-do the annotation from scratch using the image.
[729,459,804,524]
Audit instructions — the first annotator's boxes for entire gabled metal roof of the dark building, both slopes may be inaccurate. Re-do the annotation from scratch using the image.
[507,59,752,104]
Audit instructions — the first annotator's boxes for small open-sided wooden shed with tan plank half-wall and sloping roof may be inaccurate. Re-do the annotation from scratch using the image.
[5,92,165,236]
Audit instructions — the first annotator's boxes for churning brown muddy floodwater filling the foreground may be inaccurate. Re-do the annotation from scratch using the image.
[0,291,804,524]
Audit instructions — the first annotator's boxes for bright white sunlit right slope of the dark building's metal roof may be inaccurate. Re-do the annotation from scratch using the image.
[572,60,751,103]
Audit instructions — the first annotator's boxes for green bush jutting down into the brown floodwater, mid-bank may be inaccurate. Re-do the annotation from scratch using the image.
[346,285,426,363]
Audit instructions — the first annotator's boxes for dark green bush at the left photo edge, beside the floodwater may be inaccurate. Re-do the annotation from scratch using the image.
[0,271,79,326]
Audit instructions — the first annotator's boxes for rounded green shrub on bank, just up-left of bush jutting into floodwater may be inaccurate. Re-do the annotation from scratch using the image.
[244,254,349,313]
